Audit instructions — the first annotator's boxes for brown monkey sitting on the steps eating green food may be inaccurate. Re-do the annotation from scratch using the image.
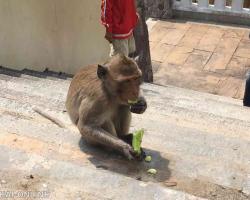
[65,54,147,160]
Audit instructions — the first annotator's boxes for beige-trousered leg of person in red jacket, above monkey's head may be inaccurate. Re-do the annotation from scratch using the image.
[110,39,129,57]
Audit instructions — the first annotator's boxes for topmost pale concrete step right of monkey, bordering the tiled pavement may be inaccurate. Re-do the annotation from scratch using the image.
[143,84,250,121]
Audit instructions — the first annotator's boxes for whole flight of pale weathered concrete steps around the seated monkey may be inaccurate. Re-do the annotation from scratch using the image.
[0,68,250,200]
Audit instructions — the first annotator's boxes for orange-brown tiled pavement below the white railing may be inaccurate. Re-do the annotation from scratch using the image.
[148,20,250,99]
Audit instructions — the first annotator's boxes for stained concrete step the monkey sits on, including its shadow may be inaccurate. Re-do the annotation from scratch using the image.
[0,102,250,199]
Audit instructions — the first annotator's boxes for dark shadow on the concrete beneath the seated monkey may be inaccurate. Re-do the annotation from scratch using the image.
[79,138,171,182]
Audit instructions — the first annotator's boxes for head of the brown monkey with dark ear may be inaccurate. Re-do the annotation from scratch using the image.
[97,54,142,104]
